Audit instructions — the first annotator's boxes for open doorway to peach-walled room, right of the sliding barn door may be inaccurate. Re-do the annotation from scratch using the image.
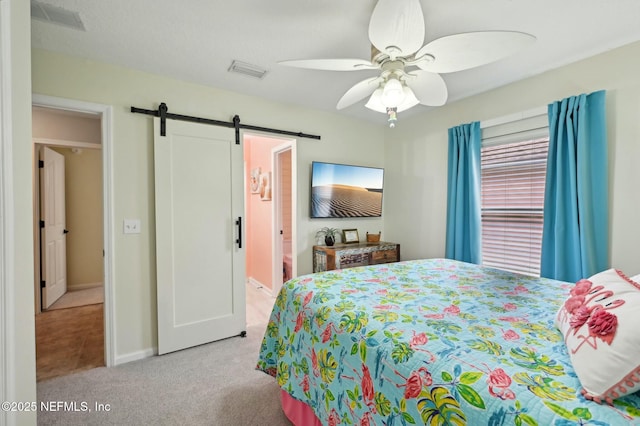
[243,133,297,325]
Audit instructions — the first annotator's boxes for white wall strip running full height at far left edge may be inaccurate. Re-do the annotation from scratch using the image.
[0,0,36,425]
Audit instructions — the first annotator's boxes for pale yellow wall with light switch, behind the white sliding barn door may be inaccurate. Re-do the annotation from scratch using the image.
[31,49,384,358]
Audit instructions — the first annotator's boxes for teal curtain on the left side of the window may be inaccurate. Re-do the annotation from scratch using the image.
[445,121,482,264]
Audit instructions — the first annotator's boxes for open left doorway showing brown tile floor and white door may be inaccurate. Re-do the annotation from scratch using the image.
[32,95,113,380]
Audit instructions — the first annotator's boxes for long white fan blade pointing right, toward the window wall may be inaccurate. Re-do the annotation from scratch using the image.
[414,31,536,73]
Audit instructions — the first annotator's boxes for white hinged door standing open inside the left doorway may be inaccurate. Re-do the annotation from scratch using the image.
[40,147,67,309]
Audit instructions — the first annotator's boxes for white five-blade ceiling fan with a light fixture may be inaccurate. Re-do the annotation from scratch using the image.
[279,0,535,127]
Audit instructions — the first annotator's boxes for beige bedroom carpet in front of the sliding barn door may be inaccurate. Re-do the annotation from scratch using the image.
[38,325,291,426]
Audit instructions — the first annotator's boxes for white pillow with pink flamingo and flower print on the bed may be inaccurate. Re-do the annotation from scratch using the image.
[556,269,640,404]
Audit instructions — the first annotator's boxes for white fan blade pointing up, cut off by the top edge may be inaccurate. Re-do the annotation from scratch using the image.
[369,0,424,60]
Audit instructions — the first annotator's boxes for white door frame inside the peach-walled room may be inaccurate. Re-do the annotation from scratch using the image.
[271,139,298,296]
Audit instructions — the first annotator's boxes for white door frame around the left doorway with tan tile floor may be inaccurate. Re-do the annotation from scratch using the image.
[32,93,116,367]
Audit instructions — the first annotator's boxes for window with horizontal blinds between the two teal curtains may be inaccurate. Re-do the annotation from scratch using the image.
[480,110,549,276]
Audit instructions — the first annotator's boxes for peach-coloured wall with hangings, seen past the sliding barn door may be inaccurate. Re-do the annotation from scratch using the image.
[244,137,282,289]
